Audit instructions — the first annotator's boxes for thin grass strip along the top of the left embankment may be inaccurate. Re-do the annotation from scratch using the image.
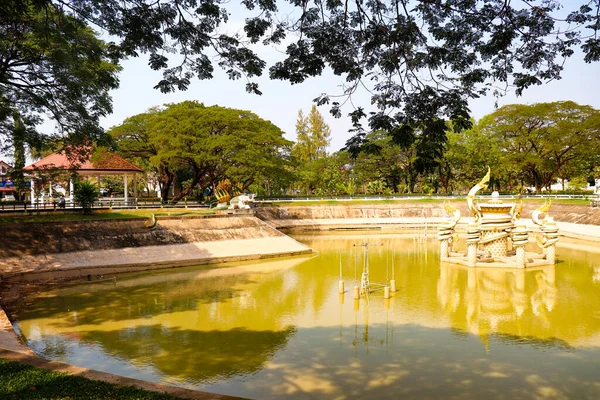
[0,208,215,224]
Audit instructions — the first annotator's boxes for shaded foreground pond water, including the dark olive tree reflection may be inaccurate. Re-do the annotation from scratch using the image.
[76,324,600,399]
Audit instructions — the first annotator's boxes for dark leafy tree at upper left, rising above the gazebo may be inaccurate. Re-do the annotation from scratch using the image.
[0,0,119,151]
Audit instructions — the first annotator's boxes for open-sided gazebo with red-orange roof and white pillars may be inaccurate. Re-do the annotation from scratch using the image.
[23,150,144,205]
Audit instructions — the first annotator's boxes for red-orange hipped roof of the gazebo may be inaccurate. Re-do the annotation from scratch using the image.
[23,151,143,172]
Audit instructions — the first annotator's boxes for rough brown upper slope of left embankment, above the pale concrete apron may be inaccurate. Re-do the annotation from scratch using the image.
[0,216,288,258]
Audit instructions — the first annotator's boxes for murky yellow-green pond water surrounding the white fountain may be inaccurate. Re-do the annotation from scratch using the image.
[10,232,600,400]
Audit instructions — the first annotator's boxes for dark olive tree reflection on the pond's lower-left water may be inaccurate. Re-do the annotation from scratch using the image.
[83,325,295,384]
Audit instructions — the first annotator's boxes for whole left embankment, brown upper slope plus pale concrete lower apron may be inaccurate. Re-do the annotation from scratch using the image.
[0,216,312,282]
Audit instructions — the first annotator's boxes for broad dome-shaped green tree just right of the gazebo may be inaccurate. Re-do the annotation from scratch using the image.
[110,101,291,201]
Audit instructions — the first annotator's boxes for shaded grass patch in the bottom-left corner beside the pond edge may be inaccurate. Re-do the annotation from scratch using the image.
[0,359,184,400]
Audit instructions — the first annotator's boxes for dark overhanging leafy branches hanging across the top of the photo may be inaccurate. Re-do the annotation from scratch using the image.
[5,0,600,150]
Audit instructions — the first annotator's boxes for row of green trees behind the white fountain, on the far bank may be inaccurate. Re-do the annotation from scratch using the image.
[286,101,600,194]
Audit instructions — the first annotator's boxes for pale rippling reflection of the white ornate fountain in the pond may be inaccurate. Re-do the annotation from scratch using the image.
[438,264,557,350]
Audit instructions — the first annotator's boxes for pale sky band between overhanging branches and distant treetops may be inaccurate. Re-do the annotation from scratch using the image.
[101,48,600,152]
